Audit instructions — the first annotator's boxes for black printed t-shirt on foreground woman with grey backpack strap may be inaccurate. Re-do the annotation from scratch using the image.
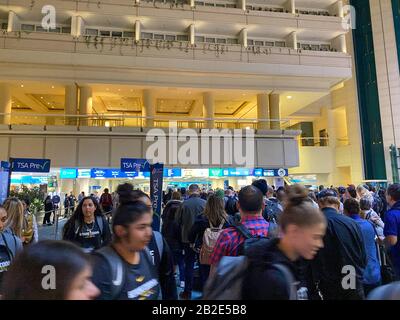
[92,251,160,300]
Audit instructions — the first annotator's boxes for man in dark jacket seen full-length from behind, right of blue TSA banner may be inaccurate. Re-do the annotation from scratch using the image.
[175,184,206,299]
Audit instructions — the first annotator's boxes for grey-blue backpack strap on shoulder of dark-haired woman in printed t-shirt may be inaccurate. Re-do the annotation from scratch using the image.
[95,246,126,300]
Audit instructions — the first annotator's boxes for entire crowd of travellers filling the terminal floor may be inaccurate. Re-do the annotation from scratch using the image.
[0,179,400,300]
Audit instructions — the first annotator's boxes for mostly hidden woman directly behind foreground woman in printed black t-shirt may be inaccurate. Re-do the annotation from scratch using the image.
[117,183,178,300]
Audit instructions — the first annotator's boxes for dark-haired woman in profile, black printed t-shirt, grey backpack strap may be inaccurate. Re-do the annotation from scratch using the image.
[93,198,160,300]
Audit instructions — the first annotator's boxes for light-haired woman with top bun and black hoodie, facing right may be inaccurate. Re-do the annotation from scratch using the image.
[243,185,326,300]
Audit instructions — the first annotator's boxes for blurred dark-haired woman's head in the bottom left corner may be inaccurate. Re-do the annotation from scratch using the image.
[2,240,99,300]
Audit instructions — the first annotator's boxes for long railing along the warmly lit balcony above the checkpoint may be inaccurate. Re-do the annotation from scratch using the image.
[0,113,349,147]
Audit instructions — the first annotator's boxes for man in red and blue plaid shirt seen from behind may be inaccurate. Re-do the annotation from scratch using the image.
[210,186,269,272]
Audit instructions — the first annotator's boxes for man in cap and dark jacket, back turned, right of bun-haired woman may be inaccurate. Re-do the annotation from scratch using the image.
[310,189,367,300]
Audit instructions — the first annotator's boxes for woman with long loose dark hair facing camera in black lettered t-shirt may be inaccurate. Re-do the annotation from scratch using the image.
[63,197,111,253]
